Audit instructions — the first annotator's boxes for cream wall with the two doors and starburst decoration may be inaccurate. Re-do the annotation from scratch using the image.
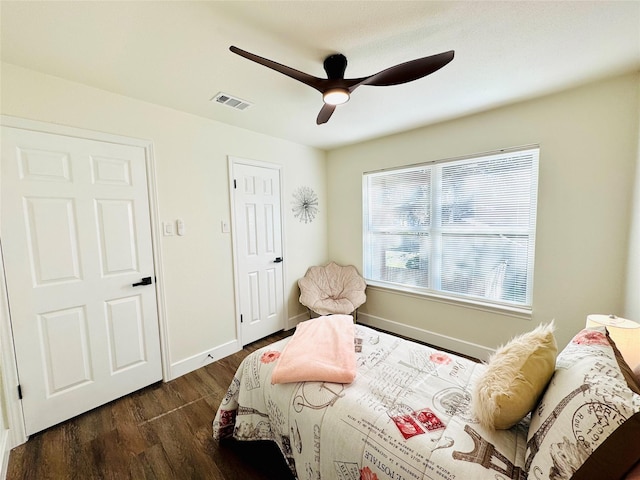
[1,64,327,378]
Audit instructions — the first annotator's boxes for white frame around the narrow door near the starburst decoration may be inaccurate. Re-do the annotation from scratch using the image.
[227,155,289,350]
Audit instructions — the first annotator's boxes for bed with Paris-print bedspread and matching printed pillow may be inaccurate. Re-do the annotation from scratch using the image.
[213,317,640,480]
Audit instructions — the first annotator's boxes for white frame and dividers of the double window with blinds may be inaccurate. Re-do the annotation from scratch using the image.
[362,145,540,316]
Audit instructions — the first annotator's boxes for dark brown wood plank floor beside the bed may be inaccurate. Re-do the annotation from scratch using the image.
[7,330,293,480]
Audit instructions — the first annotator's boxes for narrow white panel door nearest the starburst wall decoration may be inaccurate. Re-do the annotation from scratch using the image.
[233,163,284,345]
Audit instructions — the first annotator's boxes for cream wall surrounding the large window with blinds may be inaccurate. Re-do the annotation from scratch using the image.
[328,74,640,354]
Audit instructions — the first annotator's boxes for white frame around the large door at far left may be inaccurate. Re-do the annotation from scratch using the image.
[0,115,171,446]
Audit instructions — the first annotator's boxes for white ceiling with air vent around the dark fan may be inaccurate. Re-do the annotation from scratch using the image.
[0,0,640,149]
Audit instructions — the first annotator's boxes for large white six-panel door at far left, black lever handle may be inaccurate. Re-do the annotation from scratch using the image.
[0,127,162,435]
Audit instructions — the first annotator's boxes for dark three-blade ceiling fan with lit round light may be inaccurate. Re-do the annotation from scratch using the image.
[229,46,453,125]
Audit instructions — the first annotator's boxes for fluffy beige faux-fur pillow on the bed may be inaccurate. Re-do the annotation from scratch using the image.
[472,322,558,430]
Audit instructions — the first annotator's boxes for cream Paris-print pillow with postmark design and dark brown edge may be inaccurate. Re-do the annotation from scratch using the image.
[525,327,640,480]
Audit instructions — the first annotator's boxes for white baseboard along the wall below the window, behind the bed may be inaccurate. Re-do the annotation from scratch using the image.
[358,312,495,361]
